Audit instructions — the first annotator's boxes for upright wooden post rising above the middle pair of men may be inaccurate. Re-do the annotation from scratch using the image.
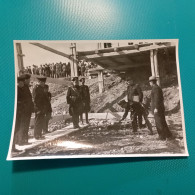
[70,43,78,77]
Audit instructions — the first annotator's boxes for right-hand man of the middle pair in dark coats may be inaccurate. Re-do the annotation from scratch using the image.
[80,78,90,124]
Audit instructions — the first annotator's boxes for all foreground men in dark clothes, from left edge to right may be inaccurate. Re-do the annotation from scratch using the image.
[12,71,172,152]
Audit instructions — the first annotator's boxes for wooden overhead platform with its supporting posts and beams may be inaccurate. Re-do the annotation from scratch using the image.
[16,42,176,93]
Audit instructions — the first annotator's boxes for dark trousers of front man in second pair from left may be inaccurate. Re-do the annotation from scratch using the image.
[34,113,45,138]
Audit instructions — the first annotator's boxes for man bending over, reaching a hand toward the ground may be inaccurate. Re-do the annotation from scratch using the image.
[118,100,153,135]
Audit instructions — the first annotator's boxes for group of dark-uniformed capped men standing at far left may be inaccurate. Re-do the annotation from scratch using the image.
[12,74,52,152]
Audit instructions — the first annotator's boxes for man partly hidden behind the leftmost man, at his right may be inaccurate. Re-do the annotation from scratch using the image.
[22,74,34,144]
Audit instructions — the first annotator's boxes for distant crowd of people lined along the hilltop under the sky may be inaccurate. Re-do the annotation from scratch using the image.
[22,60,97,78]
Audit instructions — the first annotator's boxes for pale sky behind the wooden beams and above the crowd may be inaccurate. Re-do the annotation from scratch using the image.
[21,40,133,67]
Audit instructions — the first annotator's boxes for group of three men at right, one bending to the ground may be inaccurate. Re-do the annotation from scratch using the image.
[118,76,172,140]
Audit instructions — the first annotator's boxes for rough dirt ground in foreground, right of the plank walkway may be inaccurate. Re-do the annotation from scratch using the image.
[17,111,184,157]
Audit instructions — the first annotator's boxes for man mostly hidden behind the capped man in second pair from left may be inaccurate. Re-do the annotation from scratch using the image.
[43,85,52,134]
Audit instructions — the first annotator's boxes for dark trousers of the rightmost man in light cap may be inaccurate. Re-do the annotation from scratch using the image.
[154,112,172,139]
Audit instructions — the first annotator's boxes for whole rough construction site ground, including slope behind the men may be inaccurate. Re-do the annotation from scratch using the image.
[13,75,185,157]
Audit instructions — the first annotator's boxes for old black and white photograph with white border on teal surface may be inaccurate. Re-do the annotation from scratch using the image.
[7,39,188,160]
